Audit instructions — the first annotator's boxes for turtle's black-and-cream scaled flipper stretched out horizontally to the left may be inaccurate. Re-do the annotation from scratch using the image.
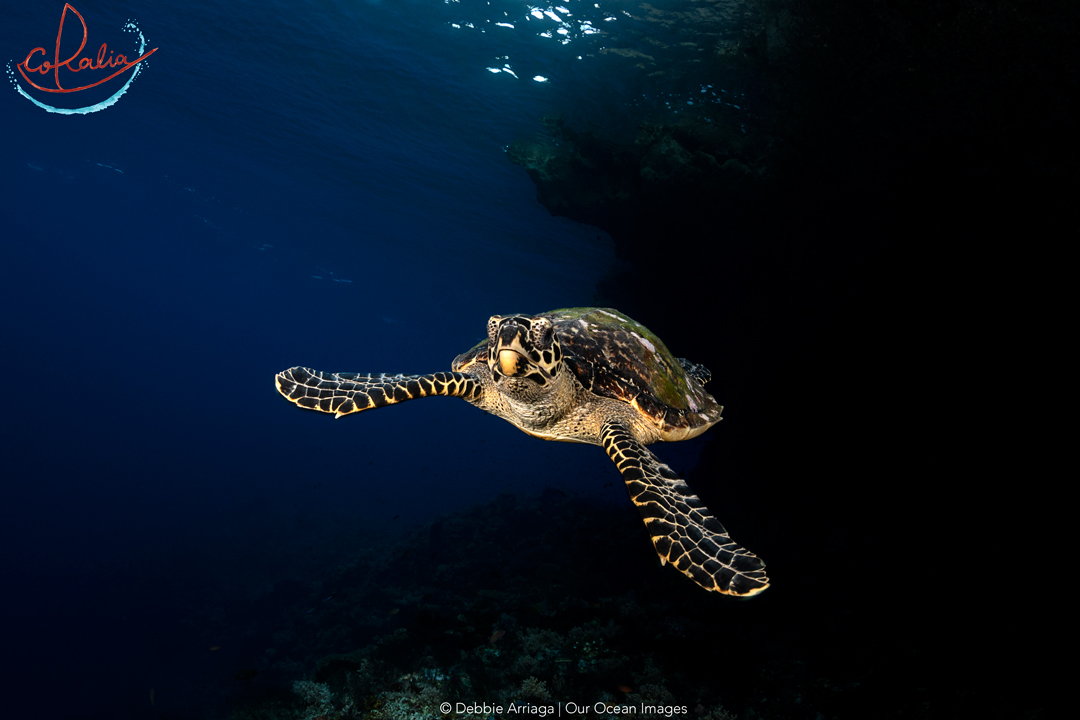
[274,367,482,418]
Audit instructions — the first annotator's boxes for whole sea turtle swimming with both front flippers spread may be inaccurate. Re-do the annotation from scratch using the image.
[275,308,769,597]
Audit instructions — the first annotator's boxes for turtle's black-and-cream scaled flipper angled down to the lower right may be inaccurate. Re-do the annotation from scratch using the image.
[600,422,769,597]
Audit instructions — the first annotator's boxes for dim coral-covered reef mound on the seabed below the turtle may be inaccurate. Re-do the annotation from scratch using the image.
[225,491,768,720]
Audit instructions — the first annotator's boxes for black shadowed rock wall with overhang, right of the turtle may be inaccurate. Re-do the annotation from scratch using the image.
[498,2,1080,717]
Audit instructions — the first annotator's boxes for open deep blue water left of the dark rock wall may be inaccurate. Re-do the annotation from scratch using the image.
[0,0,738,718]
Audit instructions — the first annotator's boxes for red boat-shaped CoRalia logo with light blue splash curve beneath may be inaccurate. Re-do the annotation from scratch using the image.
[8,3,158,114]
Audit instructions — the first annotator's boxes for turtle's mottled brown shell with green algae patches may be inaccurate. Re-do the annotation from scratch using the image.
[454,308,721,440]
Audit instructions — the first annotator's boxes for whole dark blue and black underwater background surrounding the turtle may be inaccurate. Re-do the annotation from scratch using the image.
[0,0,1062,719]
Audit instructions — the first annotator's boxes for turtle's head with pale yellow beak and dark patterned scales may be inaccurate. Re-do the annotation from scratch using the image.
[487,315,563,386]
